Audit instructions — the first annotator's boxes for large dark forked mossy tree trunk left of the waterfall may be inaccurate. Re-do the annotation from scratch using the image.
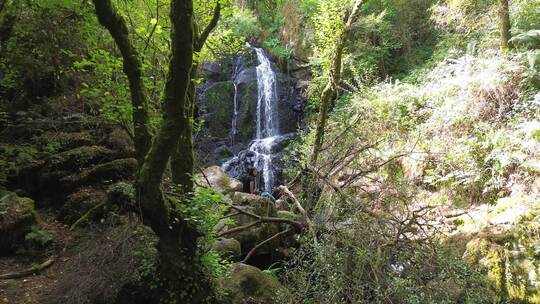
[93,0,219,303]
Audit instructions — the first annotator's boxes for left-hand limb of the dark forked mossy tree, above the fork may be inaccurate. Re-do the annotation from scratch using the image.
[93,0,152,167]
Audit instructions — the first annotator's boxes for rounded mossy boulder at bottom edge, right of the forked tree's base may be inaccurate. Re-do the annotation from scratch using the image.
[220,263,282,304]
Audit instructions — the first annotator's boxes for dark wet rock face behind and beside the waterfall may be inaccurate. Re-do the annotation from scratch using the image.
[195,50,306,179]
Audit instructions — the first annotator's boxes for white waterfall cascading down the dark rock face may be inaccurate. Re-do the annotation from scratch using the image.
[222,48,290,191]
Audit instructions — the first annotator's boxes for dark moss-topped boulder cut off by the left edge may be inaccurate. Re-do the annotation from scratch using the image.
[0,192,37,253]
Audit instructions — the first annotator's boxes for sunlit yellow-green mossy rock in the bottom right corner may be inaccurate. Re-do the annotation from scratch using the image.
[448,198,540,303]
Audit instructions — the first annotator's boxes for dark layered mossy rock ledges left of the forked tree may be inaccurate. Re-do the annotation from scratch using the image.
[0,115,137,224]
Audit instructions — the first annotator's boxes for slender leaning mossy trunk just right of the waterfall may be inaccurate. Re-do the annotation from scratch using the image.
[310,0,362,166]
